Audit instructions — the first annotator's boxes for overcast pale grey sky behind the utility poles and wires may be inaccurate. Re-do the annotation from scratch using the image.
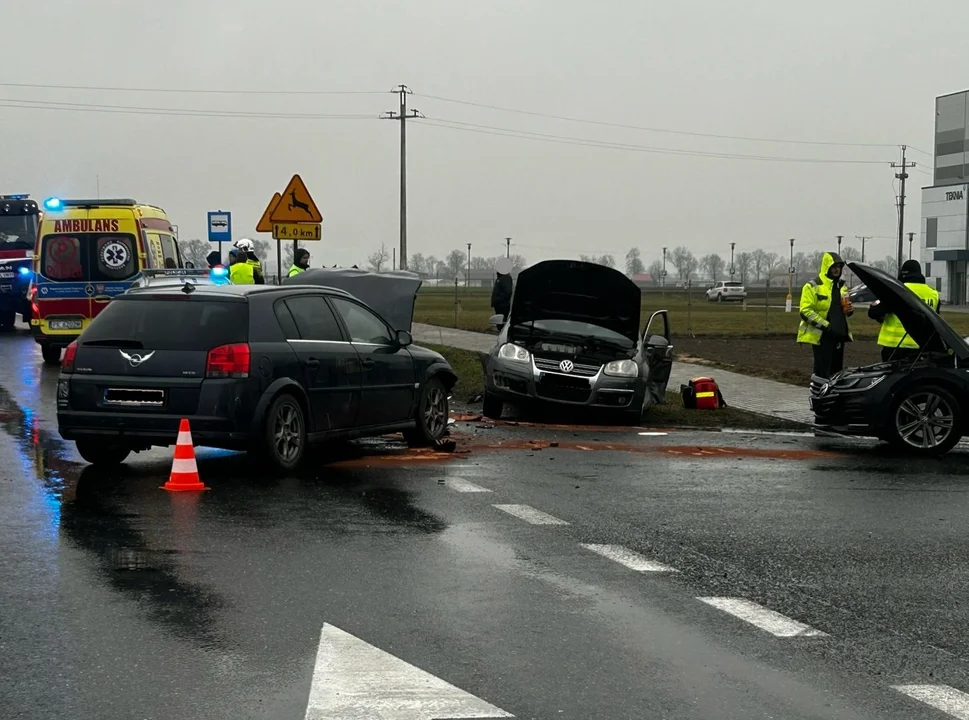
[0,0,969,265]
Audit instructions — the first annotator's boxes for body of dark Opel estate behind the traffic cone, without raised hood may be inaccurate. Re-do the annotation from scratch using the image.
[57,282,457,469]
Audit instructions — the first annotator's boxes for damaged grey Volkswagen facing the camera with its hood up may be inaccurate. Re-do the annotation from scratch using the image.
[484,260,673,423]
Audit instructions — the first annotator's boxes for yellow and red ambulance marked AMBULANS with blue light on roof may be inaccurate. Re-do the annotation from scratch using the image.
[28,198,184,364]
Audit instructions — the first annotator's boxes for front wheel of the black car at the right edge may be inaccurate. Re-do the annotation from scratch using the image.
[889,385,962,455]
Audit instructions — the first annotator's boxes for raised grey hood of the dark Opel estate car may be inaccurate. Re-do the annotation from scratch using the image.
[283,268,422,332]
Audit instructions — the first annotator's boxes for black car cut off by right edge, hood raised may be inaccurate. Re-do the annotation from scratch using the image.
[811,263,969,455]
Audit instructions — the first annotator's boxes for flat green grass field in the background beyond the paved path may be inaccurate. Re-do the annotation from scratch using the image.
[414,288,969,339]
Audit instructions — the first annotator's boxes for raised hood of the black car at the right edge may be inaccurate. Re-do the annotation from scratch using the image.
[848,262,969,359]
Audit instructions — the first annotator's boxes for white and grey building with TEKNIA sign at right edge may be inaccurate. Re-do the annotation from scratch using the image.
[920,90,969,305]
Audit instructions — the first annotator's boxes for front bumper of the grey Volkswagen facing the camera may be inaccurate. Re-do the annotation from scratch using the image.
[485,357,645,410]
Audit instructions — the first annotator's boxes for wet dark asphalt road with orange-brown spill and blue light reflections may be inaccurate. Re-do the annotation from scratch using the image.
[0,333,969,720]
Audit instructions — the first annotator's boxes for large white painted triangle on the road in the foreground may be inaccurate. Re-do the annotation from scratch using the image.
[306,625,514,720]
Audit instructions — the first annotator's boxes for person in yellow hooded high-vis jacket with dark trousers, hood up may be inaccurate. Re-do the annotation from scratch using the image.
[797,252,854,379]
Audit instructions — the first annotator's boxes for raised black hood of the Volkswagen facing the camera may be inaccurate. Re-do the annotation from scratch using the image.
[509,260,642,343]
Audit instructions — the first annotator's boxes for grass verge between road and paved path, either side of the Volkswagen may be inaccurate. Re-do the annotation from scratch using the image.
[425,345,803,430]
